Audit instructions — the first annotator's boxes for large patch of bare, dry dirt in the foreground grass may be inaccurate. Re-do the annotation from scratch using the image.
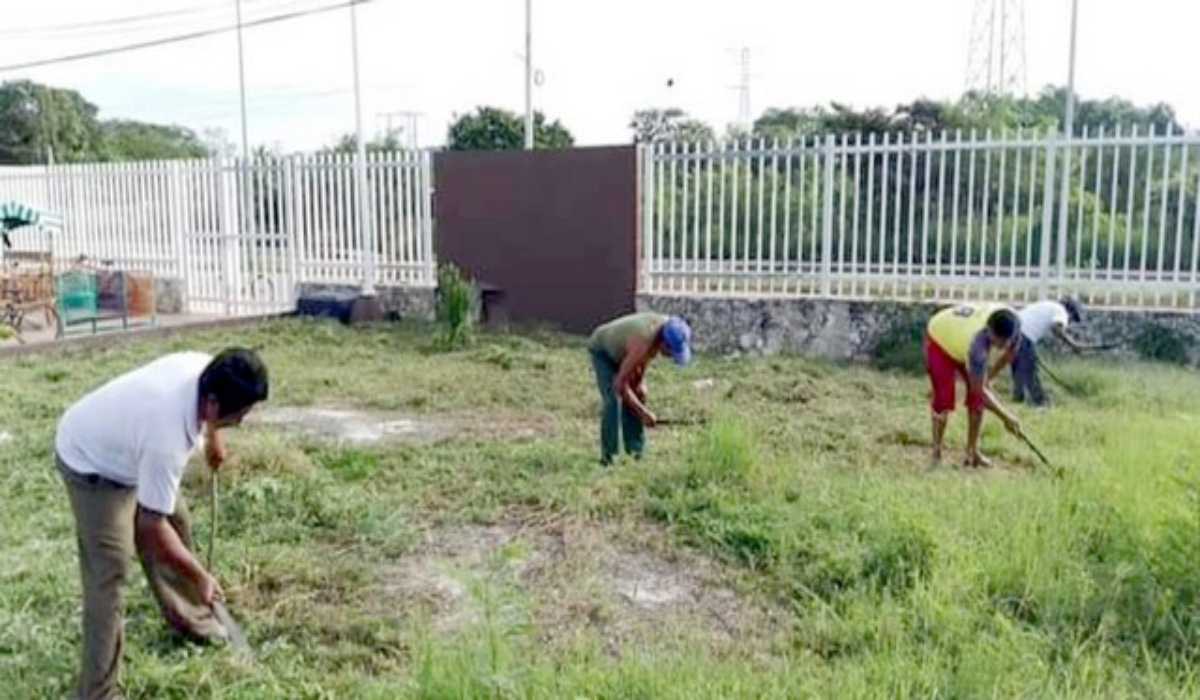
[380,523,784,653]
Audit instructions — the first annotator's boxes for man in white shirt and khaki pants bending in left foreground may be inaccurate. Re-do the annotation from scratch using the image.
[54,348,268,699]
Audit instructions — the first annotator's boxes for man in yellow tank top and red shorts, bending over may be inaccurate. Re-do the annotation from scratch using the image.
[924,303,1021,467]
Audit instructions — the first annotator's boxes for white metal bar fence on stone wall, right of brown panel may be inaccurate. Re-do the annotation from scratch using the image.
[640,130,1200,310]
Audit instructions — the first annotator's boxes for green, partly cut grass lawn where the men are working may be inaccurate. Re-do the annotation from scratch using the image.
[0,321,1200,699]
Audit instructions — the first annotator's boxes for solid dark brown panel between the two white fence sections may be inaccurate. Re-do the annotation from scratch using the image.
[433,146,637,333]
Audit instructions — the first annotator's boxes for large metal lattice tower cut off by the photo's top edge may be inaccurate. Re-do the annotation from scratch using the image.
[966,0,1028,96]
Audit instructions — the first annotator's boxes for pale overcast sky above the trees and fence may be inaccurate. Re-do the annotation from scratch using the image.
[0,0,1200,149]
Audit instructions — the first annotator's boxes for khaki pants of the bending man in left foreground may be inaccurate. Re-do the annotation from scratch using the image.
[55,455,224,700]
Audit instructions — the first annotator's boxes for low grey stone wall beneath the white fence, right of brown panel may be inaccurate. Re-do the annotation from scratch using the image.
[637,295,1200,365]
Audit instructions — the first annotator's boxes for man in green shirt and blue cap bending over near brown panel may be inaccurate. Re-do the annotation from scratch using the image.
[588,312,691,466]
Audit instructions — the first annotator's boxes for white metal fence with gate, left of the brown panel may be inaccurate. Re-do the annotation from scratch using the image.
[0,151,436,315]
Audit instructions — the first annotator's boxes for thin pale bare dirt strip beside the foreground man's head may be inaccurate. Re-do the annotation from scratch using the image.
[246,406,550,444]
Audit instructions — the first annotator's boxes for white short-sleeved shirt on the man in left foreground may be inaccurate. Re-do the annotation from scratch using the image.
[54,352,212,515]
